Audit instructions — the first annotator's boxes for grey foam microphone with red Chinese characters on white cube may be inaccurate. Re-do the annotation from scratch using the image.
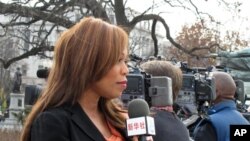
[126,98,155,141]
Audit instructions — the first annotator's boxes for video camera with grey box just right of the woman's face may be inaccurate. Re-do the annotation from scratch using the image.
[121,68,173,107]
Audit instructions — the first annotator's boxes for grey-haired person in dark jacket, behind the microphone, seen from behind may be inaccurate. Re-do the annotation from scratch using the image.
[141,60,189,141]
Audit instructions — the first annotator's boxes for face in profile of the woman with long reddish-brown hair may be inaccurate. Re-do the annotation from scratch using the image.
[91,48,129,99]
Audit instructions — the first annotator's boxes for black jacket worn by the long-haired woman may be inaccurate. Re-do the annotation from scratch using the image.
[30,104,130,141]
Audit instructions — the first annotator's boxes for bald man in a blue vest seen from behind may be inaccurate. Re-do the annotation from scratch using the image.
[194,72,249,141]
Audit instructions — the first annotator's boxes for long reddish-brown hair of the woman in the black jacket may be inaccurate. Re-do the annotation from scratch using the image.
[21,17,128,141]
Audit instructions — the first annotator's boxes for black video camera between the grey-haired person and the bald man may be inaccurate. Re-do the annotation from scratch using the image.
[176,63,216,115]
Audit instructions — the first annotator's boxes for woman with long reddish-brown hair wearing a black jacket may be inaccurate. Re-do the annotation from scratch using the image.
[21,17,132,141]
